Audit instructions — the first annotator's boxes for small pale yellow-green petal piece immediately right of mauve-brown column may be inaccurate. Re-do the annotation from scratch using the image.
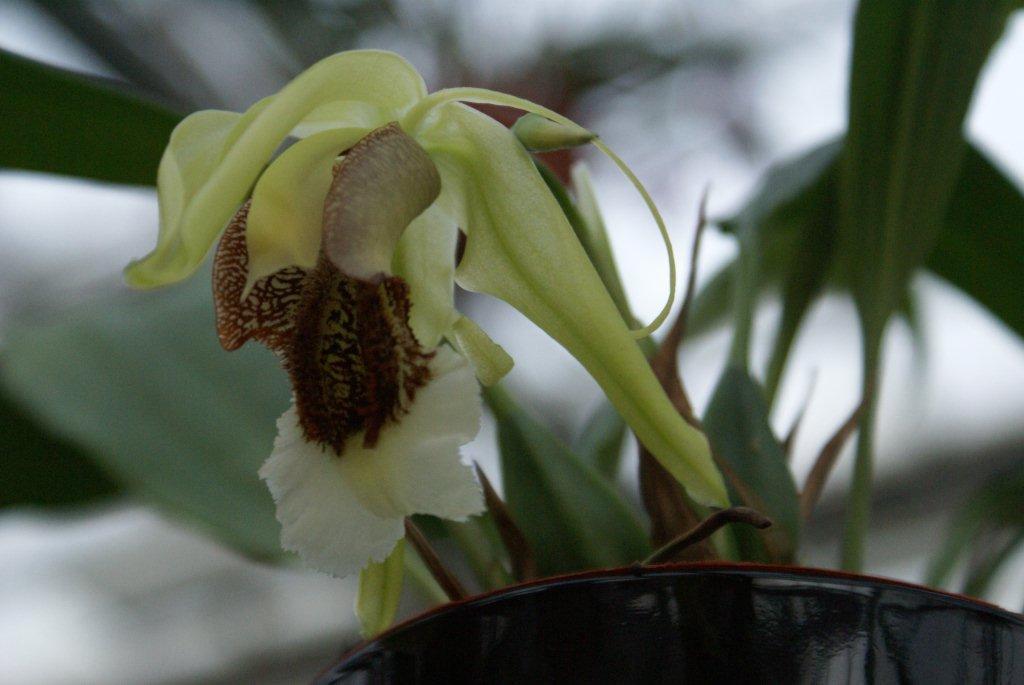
[391,203,459,349]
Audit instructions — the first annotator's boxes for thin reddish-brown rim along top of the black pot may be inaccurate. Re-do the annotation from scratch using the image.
[324,560,1024,673]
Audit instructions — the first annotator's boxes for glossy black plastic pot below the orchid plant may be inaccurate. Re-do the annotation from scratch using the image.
[315,564,1024,685]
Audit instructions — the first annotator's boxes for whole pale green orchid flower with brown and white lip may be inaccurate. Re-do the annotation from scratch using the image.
[126,50,726,575]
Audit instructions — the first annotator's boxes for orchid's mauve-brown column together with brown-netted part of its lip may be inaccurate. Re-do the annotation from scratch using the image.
[213,124,440,455]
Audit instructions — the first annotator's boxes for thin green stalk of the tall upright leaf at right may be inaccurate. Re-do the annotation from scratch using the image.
[842,331,882,572]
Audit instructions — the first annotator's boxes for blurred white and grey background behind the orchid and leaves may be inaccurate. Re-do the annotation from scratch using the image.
[0,0,1024,684]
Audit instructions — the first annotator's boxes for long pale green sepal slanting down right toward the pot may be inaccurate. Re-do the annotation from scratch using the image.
[419,103,728,505]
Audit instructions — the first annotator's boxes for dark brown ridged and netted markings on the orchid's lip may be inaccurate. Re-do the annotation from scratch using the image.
[215,231,433,455]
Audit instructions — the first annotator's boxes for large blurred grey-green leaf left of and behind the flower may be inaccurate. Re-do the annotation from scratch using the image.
[0,270,289,557]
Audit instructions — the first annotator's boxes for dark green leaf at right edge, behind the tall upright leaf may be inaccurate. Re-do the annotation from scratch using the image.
[926,148,1024,336]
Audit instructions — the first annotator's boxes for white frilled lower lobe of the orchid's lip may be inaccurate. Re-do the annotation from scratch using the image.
[260,348,483,577]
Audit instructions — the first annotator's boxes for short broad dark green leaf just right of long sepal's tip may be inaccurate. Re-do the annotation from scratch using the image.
[703,366,800,563]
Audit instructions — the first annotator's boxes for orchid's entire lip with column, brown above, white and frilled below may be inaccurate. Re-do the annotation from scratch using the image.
[213,124,483,576]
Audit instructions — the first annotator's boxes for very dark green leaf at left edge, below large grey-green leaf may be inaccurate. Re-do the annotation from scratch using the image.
[0,391,123,508]
